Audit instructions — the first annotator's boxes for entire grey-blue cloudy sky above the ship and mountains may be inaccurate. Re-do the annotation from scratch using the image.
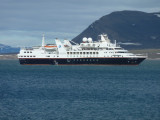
[0,0,160,47]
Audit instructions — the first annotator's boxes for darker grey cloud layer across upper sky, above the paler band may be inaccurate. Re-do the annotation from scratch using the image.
[0,0,160,32]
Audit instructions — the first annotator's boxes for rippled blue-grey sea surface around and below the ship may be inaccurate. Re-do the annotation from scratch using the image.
[0,60,160,120]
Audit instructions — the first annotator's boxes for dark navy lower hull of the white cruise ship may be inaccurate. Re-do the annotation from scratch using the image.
[19,58,145,65]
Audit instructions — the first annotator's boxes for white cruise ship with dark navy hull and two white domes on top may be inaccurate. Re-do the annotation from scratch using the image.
[18,34,147,65]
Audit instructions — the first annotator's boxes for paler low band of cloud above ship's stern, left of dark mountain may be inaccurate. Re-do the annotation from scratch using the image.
[0,30,76,47]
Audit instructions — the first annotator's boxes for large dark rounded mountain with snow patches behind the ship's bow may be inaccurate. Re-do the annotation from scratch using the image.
[73,11,160,49]
